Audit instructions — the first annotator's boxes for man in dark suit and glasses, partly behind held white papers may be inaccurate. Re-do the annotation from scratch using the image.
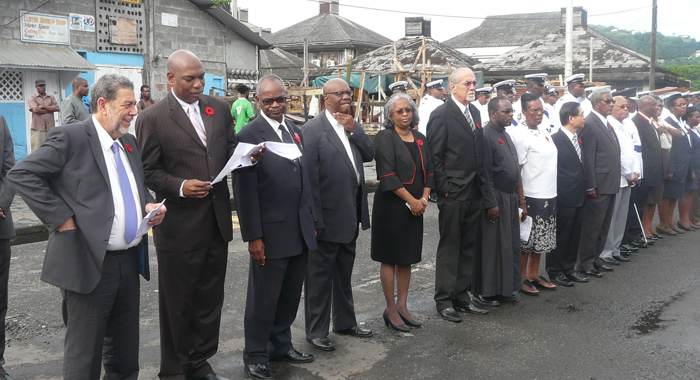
[233,75,317,379]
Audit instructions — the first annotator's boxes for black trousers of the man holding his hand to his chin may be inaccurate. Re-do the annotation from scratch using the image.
[304,235,359,339]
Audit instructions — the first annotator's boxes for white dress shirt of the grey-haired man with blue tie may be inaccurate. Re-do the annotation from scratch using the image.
[92,116,143,251]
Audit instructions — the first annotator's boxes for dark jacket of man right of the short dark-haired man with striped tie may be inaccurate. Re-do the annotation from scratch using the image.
[579,112,620,195]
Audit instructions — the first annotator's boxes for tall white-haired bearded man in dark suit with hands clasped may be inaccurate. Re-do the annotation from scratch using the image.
[428,68,497,322]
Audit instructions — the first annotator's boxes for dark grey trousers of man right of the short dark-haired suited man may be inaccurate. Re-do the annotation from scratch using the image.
[577,194,617,271]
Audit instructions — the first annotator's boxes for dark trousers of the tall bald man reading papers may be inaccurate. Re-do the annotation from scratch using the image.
[156,235,228,380]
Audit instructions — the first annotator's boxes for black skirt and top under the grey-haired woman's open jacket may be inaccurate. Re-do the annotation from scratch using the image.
[371,141,425,265]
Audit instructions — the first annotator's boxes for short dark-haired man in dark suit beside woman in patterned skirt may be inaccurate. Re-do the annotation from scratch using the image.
[547,102,588,286]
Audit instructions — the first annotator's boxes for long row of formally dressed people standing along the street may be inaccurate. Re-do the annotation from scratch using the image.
[0,50,700,380]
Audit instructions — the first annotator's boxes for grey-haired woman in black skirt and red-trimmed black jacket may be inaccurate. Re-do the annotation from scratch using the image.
[372,93,434,332]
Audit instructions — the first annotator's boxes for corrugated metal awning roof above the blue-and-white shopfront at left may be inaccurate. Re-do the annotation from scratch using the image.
[0,45,96,71]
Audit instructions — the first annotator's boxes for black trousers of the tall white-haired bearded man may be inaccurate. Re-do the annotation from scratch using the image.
[434,197,481,310]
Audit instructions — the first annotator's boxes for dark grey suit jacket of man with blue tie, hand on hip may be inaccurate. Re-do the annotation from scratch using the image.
[7,118,154,294]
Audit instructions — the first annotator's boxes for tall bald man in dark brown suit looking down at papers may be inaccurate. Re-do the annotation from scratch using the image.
[136,50,242,380]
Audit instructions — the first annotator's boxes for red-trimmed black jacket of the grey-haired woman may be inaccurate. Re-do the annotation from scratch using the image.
[374,129,435,193]
